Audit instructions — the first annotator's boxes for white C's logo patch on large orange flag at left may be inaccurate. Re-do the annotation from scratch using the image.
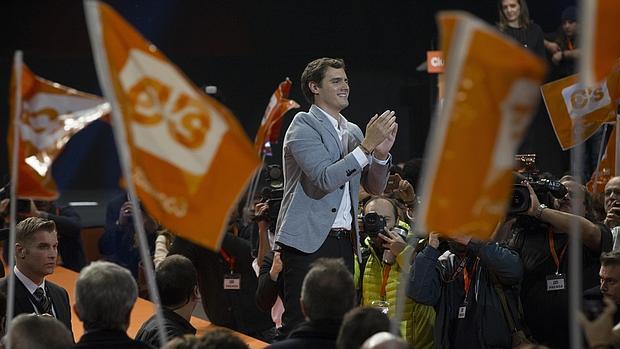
[120,49,228,175]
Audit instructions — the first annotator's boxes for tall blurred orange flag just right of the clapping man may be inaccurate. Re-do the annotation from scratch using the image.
[419,12,545,239]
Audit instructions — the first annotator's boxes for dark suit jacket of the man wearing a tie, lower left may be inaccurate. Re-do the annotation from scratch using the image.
[0,276,73,334]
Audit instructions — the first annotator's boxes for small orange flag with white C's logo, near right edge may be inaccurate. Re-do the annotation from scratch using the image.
[541,71,620,150]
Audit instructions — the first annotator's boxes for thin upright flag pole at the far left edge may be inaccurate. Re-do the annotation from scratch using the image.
[6,50,22,349]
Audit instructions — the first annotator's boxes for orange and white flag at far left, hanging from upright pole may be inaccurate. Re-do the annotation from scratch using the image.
[8,57,110,200]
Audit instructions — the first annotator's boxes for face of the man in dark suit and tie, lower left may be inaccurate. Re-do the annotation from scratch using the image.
[16,230,58,278]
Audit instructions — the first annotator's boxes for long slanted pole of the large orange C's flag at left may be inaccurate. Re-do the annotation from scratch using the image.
[84,0,168,345]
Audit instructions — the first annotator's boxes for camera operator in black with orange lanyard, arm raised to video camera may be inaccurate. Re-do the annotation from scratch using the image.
[510,177,612,348]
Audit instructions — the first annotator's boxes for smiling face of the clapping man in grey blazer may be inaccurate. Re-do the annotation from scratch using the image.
[310,67,349,112]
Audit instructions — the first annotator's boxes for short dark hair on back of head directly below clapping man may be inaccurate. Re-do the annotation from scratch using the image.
[301,258,355,321]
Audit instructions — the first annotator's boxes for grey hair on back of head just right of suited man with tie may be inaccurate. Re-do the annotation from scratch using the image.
[75,261,138,331]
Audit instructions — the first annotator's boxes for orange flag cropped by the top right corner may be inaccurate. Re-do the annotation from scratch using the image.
[579,0,620,87]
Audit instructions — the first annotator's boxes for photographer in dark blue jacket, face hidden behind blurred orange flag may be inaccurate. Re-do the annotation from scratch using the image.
[407,233,523,349]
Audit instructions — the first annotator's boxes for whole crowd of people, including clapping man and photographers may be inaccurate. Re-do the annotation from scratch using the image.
[0,0,620,349]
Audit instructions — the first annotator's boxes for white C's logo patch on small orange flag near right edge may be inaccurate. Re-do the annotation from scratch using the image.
[562,82,611,119]
